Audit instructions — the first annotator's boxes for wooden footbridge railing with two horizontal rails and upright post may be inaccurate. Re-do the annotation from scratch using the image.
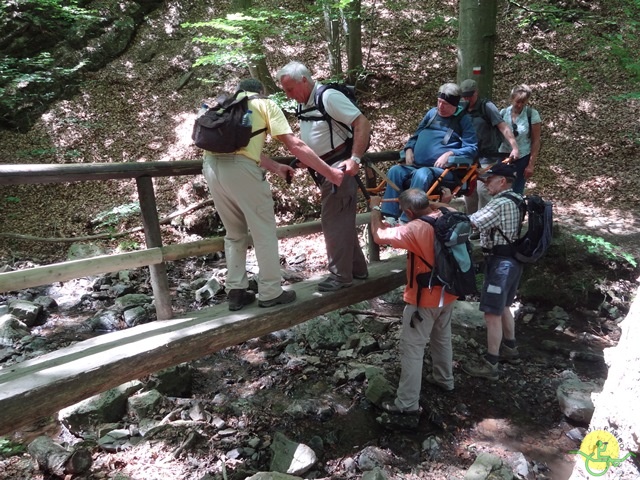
[0,151,399,320]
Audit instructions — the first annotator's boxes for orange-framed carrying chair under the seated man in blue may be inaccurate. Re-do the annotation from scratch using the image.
[367,157,481,201]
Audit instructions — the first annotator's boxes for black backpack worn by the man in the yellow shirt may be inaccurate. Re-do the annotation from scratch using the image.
[191,91,267,153]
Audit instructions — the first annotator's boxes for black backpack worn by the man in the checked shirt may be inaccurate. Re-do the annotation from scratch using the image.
[496,193,553,263]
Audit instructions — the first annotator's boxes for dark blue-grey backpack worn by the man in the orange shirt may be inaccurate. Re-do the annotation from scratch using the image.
[410,207,478,305]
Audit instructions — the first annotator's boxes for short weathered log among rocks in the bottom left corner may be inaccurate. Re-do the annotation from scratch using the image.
[27,436,92,477]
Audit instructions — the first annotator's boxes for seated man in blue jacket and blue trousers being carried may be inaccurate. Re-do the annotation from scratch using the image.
[382,83,478,221]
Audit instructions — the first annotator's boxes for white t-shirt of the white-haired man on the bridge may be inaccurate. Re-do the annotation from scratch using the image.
[300,83,362,156]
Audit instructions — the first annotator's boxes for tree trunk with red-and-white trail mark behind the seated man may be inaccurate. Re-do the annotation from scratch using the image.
[458,0,498,98]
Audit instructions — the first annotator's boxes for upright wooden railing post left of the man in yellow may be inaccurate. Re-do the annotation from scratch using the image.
[136,177,173,320]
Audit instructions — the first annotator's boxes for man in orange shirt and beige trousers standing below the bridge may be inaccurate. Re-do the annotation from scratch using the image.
[371,188,458,414]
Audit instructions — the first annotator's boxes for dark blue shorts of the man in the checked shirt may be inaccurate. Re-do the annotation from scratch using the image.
[480,255,522,315]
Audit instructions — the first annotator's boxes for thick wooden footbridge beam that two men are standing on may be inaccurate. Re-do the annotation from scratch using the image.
[0,256,406,435]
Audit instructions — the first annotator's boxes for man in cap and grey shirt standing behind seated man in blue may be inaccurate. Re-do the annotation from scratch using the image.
[460,79,520,215]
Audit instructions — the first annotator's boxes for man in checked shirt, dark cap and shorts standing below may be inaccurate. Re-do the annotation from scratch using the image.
[462,162,522,380]
